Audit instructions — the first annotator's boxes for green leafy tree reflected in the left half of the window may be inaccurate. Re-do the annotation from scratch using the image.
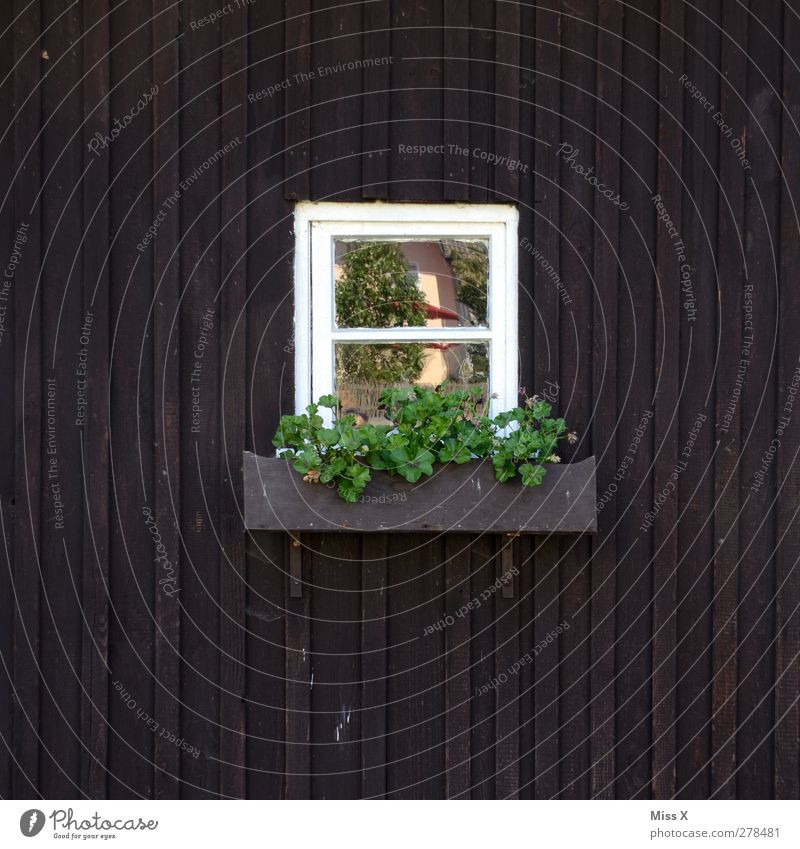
[336,242,427,383]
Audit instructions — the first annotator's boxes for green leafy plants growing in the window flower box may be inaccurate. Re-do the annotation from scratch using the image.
[273,385,577,502]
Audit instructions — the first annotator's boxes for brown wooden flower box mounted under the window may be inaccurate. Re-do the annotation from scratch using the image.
[244,451,597,534]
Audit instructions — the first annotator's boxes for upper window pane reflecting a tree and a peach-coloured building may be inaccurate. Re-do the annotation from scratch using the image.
[334,239,489,327]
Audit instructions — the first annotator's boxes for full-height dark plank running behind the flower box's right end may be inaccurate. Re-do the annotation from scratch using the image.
[556,0,596,798]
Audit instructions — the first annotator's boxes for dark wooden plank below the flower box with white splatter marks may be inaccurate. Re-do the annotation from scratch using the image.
[306,534,362,799]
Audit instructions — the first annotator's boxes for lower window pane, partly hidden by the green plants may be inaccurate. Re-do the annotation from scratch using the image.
[335,342,489,424]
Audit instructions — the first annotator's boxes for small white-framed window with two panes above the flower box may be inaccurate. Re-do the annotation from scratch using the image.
[295,203,518,423]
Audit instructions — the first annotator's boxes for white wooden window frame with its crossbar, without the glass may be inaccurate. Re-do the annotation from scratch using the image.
[294,201,519,415]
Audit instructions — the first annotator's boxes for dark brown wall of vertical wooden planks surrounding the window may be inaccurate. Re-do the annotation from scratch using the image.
[0,0,800,799]
